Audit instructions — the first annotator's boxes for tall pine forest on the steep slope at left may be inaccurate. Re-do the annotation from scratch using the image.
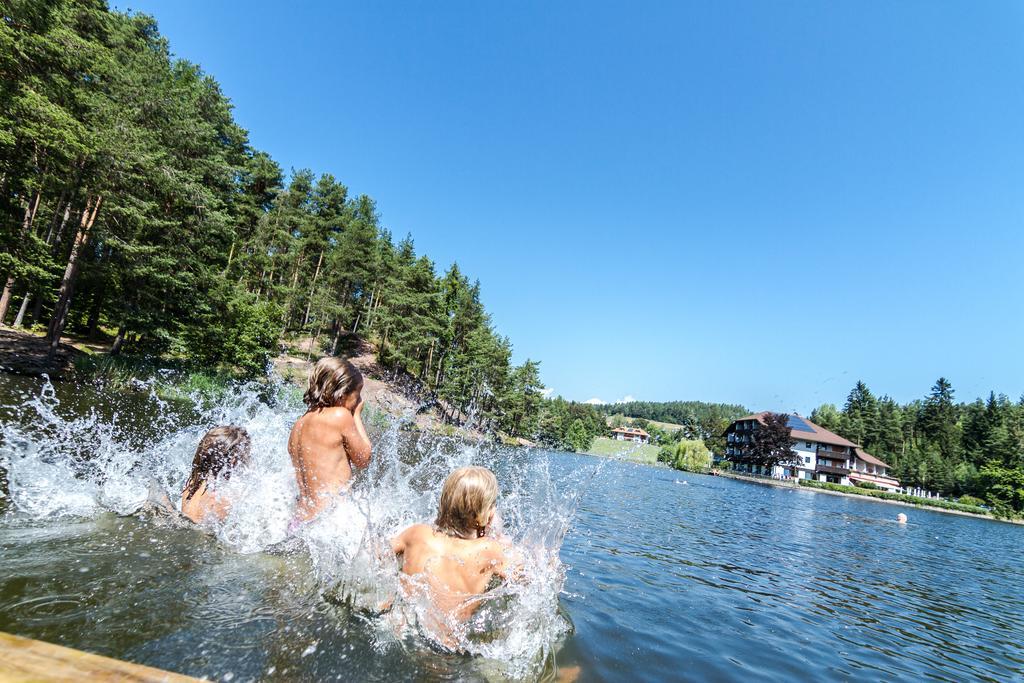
[0,0,603,446]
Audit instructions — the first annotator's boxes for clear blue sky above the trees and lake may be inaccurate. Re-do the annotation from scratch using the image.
[115,0,1024,413]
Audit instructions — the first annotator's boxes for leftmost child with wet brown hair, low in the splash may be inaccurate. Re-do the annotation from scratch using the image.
[181,425,252,524]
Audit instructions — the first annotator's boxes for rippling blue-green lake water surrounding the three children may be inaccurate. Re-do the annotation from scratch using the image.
[0,378,1024,681]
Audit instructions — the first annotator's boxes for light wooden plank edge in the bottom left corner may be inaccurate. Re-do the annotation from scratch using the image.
[0,632,199,683]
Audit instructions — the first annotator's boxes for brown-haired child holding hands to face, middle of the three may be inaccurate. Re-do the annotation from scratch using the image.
[288,356,372,523]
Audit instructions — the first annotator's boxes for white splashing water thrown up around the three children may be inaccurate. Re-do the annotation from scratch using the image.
[0,380,603,678]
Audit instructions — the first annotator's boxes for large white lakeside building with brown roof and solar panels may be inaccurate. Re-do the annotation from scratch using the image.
[724,412,900,490]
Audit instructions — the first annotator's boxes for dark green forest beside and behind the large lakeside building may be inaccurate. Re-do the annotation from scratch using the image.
[810,378,1024,516]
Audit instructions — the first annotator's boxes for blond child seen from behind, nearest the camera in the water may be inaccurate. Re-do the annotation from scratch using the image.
[391,467,521,645]
